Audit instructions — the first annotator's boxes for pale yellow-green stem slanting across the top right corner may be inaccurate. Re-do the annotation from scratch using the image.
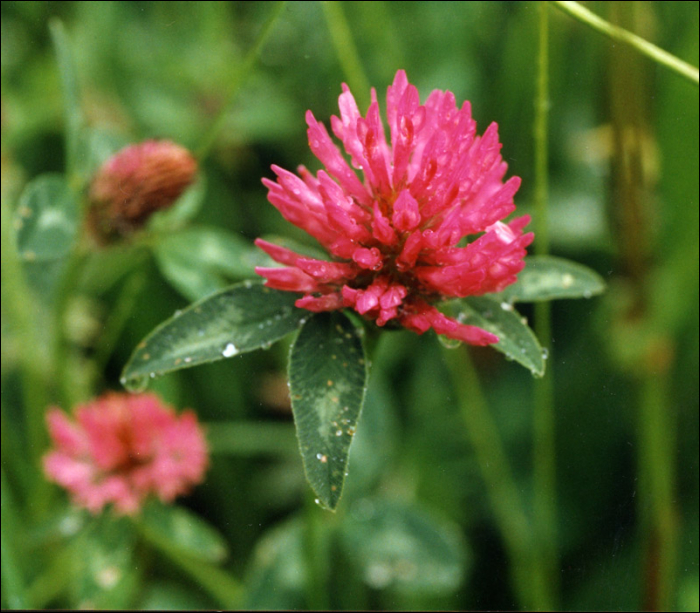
[552,1,699,85]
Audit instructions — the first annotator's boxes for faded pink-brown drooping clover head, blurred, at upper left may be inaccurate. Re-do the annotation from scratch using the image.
[89,140,197,241]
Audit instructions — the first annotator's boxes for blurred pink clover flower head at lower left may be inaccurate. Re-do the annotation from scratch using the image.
[44,393,208,514]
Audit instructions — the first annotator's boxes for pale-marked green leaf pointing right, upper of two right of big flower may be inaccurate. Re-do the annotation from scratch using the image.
[491,255,605,302]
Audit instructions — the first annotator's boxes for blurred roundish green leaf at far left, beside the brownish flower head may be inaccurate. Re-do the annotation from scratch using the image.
[15,174,79,262]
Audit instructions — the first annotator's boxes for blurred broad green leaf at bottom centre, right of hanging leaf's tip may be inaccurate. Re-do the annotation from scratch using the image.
[342,498,468,594]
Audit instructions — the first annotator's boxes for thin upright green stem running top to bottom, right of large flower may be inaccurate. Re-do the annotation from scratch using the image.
[533,1,559,609]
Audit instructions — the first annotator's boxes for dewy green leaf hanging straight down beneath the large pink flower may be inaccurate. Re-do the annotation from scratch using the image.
[289,312,368,510]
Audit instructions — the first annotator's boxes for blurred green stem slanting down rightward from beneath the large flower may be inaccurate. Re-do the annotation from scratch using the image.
[443,347,549,610]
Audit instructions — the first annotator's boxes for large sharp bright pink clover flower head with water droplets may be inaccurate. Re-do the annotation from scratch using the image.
[256,70,534,345]
